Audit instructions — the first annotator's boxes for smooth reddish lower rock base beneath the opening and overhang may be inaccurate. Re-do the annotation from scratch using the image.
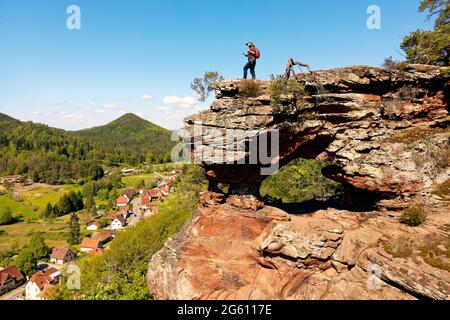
[148,193,450,300]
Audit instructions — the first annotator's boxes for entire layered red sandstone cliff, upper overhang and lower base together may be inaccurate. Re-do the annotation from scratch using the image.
[148,65,450,299]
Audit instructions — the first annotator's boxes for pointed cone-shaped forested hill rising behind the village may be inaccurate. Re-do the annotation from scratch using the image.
[74,113,175,164]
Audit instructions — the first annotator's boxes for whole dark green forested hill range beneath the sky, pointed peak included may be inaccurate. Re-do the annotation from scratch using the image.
[0,113,173,184]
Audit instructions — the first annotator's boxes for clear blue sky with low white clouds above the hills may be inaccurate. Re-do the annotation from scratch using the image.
[0,0,432,130]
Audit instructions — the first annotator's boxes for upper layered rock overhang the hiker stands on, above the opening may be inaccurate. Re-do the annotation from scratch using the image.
[182,65,450,202]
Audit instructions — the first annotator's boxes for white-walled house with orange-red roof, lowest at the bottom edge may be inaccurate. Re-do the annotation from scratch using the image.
[25,267,61,300]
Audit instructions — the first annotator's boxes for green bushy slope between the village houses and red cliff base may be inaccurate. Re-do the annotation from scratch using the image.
[74,165,206,300]
